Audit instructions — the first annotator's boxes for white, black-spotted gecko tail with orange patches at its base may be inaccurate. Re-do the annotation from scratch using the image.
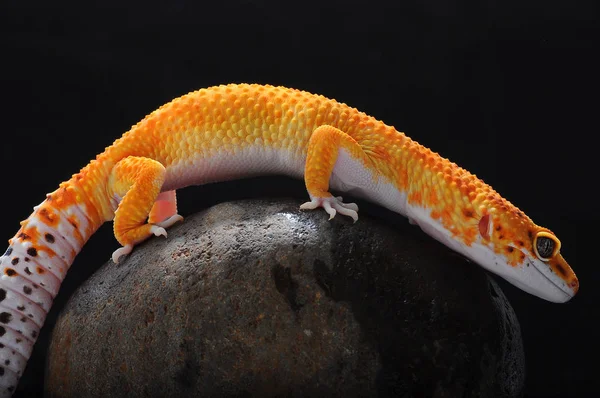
[0,190,97,398]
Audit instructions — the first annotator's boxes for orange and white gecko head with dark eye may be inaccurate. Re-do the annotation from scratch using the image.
[473,210,579,303]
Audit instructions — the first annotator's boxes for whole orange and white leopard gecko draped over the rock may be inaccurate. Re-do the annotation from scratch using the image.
[0,84,579,396]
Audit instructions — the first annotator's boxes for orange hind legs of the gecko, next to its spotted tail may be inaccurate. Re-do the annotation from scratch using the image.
[108,156,182,263]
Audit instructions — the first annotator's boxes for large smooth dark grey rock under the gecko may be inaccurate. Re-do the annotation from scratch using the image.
[45,200,524,397]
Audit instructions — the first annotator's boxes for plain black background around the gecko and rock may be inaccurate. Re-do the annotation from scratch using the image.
[0,0,600,397]
